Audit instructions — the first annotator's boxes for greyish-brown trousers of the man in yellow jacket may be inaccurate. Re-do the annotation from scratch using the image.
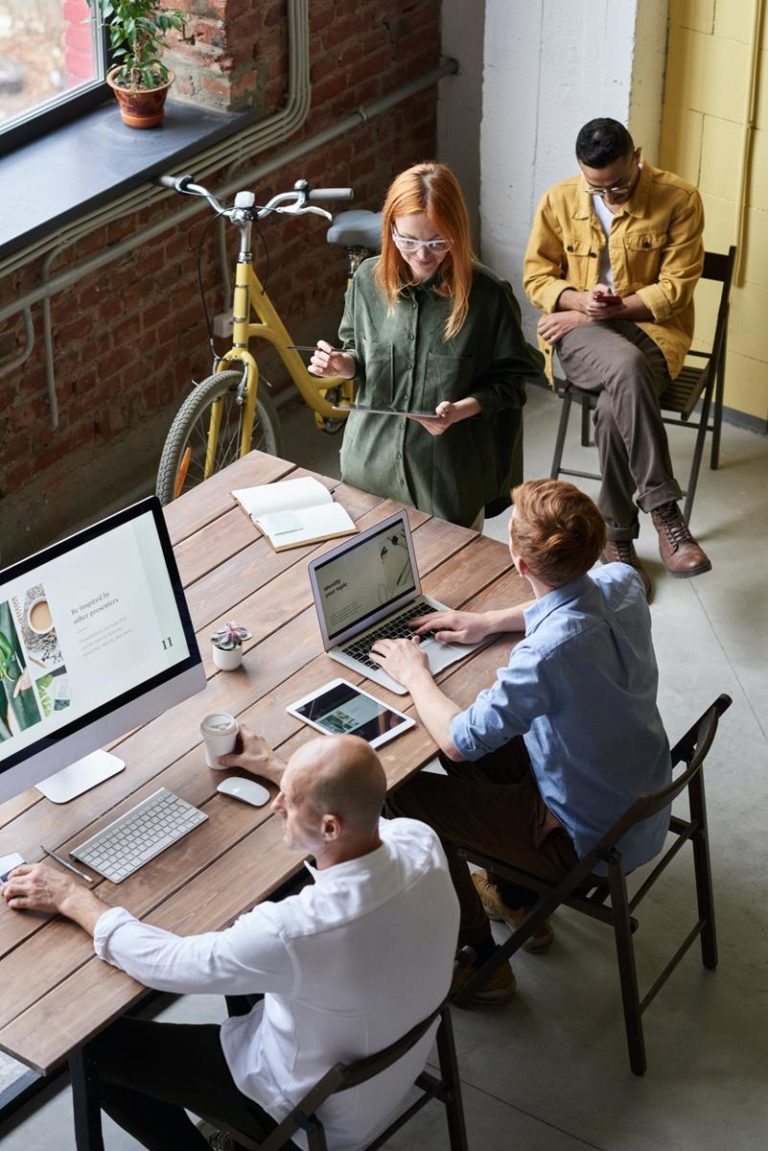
[557,320,682,540]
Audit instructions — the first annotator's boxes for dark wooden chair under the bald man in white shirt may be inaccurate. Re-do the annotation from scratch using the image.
[206,1004,467,1151]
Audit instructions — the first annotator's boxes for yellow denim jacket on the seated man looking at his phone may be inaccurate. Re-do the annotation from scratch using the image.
[523,163,704,380]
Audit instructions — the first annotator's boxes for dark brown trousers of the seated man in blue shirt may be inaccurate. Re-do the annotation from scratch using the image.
[387,737,577,946]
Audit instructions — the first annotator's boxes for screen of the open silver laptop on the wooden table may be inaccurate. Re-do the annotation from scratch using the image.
[315,524,417,640]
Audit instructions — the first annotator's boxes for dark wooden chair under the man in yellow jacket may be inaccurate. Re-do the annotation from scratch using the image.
[549,245,736,524]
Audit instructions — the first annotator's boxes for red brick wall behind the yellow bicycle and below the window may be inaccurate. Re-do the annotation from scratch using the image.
[0,0,440,562]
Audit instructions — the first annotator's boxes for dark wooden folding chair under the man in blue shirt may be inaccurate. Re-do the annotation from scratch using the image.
[453,695,731,1075]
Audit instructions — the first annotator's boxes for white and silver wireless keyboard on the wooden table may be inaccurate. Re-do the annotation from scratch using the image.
[69,787,207,883]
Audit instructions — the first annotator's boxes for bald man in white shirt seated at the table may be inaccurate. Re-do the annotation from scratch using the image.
[2,730,458,1151]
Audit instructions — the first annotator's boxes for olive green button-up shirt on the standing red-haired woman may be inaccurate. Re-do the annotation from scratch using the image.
[339,258,542,526]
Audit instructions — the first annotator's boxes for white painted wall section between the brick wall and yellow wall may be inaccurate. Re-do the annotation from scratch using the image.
[439,0,668,334]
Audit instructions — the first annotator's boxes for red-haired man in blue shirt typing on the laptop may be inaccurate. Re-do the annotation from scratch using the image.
[374,480,671,1003]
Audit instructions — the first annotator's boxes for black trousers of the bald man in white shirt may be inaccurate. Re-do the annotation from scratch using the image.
[88,1019,287,1151]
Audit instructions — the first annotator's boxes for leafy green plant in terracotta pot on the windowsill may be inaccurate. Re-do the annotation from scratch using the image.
[88,0,185,128]
